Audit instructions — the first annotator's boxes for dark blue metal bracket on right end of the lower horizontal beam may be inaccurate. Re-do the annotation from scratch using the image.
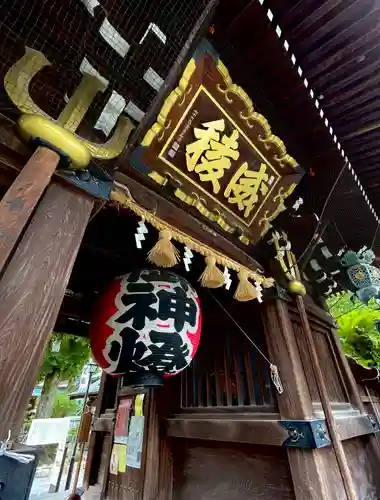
[279,419,331,449]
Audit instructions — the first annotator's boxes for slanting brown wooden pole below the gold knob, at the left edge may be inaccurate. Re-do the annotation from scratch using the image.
[0,147,59,273]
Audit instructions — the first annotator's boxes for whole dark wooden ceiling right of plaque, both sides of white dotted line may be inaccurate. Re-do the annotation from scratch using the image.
[214,0,380,251]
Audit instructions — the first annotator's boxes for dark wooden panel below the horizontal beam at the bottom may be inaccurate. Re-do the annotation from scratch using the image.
[173,439,295,500]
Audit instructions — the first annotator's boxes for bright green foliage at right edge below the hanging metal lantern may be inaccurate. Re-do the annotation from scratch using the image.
[328,293,380,367]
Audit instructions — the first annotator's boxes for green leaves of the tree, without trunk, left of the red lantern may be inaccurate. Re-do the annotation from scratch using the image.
[40,333,90,380]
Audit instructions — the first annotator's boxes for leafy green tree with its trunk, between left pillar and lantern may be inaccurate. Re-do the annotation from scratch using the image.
[36,333,90,418]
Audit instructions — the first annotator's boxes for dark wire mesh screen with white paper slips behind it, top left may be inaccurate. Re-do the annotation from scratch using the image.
[0,0,208,147]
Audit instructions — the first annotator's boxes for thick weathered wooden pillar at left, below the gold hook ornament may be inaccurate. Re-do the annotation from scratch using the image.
[0,183,93,440]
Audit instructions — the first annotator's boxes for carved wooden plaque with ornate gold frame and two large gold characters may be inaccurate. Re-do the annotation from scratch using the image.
[132,43,303,243]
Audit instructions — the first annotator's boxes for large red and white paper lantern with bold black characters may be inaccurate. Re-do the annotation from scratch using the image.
[90,269,202,377]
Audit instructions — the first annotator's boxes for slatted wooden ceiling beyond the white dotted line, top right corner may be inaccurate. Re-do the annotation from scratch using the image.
[267,0,380,197]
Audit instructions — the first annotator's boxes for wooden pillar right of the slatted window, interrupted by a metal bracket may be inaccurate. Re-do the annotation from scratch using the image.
[264,299,331,500]
